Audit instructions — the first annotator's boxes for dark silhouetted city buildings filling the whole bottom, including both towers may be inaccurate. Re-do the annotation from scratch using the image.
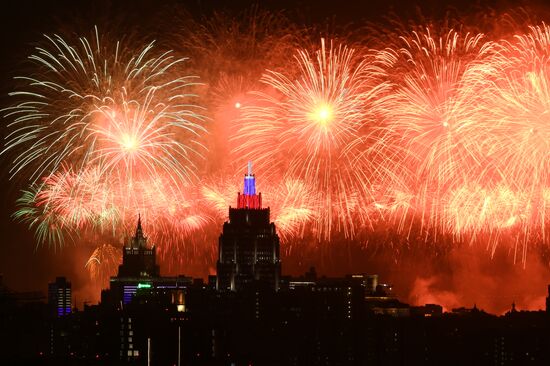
[0,167,550,365]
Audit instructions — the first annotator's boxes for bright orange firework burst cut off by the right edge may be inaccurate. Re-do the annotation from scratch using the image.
[480,25,550,193]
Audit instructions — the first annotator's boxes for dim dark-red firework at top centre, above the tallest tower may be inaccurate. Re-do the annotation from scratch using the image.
[174,6,303,95]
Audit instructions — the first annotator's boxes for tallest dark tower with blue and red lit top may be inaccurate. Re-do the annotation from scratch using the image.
[216,163,281,291]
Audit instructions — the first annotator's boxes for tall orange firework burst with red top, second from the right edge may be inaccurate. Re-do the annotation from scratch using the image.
[381,28,496,234]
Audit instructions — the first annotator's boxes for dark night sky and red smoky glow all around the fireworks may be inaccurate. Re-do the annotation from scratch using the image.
[0,0,550,312]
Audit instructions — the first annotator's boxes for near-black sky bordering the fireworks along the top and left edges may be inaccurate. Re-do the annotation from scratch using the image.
[0,0,544,312]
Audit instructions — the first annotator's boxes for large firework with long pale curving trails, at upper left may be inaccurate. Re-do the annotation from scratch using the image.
[3,29,204,186]
